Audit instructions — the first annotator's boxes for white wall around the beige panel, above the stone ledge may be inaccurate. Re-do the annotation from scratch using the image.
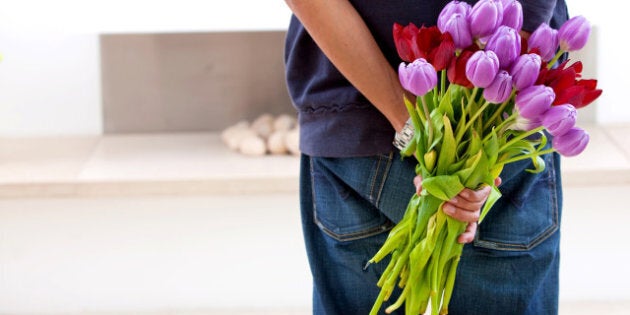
[0,0,630,136]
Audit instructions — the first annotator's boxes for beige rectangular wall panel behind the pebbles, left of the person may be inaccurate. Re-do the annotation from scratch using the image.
[100,31,295,133]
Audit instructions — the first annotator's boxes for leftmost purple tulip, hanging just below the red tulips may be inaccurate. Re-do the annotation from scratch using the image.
[398,58,437,96]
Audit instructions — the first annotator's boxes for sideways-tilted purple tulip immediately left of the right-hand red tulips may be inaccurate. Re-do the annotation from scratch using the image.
[514,85,556,120]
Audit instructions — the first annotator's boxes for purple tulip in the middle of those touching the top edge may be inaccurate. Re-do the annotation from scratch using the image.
[469,0,503,37]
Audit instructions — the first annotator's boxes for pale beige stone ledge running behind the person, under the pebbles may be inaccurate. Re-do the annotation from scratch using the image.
[0,125,630,198]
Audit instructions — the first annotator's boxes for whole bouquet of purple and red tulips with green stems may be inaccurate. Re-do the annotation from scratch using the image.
[370,0,602,314]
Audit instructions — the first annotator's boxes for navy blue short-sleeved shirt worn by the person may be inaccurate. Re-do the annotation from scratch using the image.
[285,0,568,157]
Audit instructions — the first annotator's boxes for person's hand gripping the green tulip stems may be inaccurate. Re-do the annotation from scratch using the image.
[413,176,501,244]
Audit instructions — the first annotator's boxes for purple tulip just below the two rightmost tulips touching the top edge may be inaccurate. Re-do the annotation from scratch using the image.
[486,25,521,69]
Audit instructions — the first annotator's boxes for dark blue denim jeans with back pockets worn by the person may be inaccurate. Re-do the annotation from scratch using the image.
[300,153,562,315]
